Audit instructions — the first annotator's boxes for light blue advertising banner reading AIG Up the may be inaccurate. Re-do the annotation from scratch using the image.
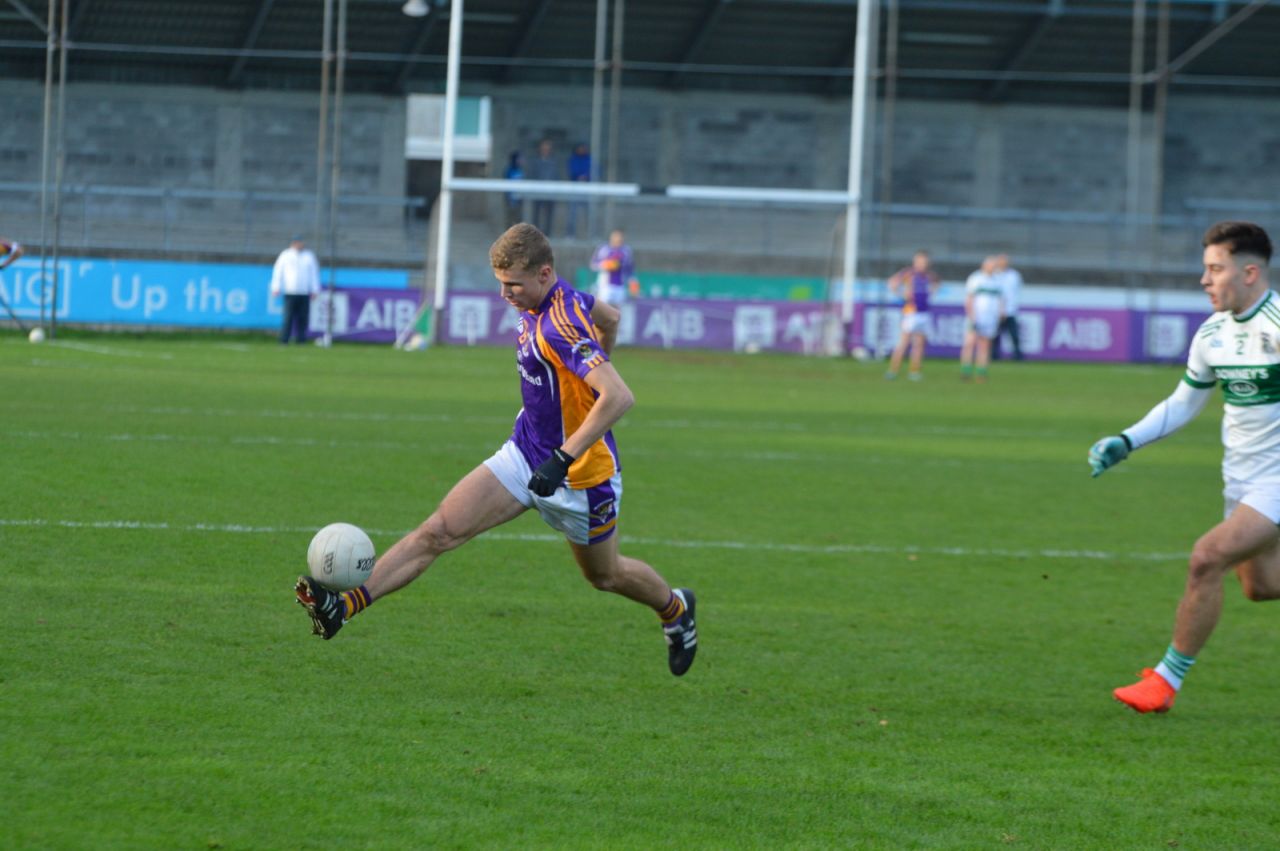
[0,257,407,329]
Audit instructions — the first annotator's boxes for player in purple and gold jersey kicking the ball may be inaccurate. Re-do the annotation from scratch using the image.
[294,223,698,677]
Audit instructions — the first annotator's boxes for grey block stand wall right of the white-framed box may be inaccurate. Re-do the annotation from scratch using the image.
[483,87,1264,212]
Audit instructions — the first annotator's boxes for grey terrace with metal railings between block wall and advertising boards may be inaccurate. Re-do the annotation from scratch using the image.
[0,183,1280,283]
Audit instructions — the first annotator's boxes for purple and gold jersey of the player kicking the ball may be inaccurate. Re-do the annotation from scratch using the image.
[511,279,622,490]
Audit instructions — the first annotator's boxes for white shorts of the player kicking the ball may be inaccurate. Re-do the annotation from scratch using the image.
[484,440,622,544]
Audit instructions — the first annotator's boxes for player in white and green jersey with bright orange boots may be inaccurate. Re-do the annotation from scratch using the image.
[1089,221,1280,713]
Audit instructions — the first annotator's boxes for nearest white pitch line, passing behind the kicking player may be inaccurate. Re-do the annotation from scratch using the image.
[0,518,1187,562]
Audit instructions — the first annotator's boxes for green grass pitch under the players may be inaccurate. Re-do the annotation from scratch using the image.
[0,334,1280,848]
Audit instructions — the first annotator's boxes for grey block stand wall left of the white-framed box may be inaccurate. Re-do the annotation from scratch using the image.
[0,82,406,220]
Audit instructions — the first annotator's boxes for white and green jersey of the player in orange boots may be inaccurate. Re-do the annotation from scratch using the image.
[1183,290,1280,481]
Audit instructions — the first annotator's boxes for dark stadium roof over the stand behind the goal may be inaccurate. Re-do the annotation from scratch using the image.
[0,0,1280,105]
